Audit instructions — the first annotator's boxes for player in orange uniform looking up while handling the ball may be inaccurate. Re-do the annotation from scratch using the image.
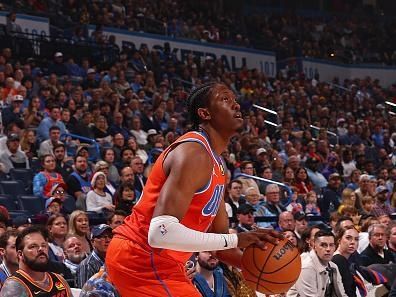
[106,83,282,297]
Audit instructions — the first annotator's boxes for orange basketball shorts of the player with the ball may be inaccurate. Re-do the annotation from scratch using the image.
[106,236,202,297]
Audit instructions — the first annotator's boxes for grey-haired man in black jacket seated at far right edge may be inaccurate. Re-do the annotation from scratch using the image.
[360,224,395,266]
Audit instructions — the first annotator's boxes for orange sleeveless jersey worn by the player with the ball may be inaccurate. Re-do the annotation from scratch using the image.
[114,132,225,265]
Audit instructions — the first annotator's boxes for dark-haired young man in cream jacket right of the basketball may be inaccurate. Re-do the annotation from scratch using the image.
[286,230,347,297]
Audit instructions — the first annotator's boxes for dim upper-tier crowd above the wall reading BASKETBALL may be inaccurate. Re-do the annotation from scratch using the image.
[6,0,396,65]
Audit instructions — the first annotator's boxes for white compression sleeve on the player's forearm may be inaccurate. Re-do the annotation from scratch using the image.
[148,215,238,252]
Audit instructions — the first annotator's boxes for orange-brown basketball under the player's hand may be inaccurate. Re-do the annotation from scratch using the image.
[242,239,301,294]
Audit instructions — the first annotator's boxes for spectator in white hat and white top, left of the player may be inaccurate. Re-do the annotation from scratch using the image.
[86,171,115,213]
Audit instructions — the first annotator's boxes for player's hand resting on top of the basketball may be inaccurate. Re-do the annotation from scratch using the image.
[237,229,283,249]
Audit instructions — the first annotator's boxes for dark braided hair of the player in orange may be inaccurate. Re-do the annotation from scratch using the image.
[187,82,216,130]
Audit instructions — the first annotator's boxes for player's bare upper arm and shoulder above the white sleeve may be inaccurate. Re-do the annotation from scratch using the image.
[153,142,213,220]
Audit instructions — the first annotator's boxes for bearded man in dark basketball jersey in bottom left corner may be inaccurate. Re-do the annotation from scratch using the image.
[1,227,72,296]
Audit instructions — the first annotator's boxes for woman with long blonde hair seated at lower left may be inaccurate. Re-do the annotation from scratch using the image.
[68,210,92,255]
